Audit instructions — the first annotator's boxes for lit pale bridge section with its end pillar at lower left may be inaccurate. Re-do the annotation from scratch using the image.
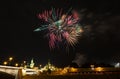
[0,65,23,79]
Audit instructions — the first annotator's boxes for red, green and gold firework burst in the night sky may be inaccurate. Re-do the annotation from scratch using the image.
[34,8,82,48]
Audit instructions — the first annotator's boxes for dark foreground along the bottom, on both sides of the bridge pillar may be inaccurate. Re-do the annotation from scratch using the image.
[0,72,120,79]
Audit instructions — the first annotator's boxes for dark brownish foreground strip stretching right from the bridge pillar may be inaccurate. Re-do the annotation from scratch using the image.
[22,73,120,79]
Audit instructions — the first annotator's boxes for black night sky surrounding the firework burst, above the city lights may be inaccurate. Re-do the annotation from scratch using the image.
[0,0,120,66]
